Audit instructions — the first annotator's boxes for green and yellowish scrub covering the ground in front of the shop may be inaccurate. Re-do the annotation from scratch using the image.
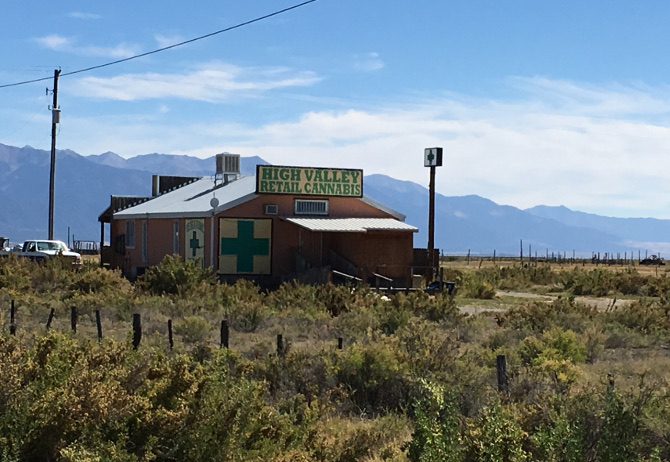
[6,258,670,462]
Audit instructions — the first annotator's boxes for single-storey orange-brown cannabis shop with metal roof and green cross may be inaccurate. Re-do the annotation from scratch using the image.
[99,154,418,287]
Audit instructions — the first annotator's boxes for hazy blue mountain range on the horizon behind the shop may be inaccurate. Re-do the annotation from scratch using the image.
[0,144,670,256]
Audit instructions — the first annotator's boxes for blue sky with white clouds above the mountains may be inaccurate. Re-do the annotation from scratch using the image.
[0,0,670,218]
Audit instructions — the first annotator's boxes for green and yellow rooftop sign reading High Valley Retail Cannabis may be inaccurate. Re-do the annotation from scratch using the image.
[256,165,363,197]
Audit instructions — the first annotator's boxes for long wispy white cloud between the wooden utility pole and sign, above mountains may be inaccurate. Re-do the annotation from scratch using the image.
[73,63,319,102]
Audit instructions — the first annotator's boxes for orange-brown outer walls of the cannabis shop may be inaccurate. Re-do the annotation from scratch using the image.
[110,191,413,277]
